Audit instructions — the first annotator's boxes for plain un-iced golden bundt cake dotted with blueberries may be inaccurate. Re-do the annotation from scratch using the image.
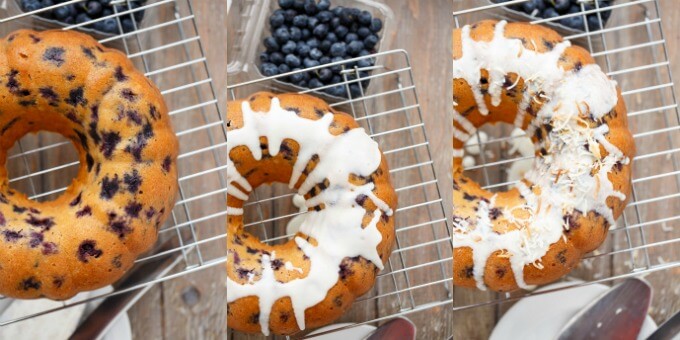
[0,30,178,299]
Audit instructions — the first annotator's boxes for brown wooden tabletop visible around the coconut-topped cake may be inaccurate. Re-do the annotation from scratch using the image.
[453,0,680,339]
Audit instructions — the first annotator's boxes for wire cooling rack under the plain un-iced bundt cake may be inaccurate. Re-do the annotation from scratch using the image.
[0,0,226,326]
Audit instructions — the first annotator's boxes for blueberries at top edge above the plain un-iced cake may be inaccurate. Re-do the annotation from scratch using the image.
[20,0,146,34]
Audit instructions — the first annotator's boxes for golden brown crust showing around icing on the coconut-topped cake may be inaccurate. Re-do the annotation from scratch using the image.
[453,20,635,292]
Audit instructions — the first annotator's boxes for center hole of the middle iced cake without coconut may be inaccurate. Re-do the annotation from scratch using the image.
[243,183,306,245]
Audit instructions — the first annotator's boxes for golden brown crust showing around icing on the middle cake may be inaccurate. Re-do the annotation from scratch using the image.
[227,92,397,335]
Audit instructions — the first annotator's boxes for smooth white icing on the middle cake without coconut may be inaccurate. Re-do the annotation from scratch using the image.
[227,98,392,335]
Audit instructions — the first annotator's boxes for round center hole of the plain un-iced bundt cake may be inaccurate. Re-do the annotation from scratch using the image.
[5,131,80,202]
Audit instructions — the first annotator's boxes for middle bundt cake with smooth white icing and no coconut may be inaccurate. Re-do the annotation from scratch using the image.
[227,92,397,335]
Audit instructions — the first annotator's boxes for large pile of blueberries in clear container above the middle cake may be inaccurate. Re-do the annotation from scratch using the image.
[260,0,383,98]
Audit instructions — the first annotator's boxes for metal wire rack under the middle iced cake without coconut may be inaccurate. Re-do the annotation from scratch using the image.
[227,50,452,339]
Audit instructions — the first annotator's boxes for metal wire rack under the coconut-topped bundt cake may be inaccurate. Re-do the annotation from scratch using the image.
[453,0,680,321]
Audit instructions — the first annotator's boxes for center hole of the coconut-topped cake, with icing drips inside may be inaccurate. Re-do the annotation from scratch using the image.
[463,123,535,192]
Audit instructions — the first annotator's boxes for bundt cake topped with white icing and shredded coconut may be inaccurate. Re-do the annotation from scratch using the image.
[453,21,635,291]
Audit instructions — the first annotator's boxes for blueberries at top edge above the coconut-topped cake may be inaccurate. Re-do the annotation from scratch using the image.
[496,0,612,31]
